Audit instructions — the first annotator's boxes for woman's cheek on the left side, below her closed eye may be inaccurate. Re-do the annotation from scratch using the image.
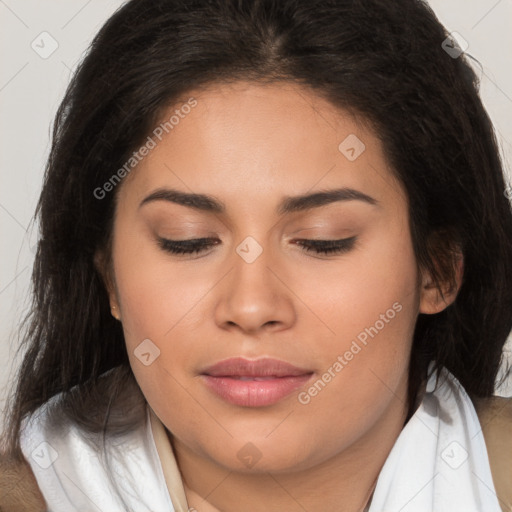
[109,226,207,392]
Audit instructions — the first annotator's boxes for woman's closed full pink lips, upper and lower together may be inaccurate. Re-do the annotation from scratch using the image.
[201,357,313,407]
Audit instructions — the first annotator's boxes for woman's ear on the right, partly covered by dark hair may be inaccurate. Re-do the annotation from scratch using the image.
[419,251,464,315]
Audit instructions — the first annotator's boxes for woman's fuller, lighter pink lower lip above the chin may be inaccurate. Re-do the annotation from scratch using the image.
[202,373,313,407]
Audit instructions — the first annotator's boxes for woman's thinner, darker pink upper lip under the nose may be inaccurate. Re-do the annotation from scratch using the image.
[202,357,313,377]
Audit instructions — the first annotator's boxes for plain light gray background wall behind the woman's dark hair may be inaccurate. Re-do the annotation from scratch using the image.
[0,0,512,429]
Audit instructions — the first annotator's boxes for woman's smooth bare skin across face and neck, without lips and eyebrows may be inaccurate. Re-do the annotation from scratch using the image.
[98,82,462,512]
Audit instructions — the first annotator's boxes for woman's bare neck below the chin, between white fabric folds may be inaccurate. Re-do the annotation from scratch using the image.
[169,372,422,512]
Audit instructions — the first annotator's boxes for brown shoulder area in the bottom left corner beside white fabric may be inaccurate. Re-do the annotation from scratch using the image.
[0,456,47,512]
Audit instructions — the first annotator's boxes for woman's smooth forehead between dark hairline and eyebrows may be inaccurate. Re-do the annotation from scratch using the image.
[115,82,403,215]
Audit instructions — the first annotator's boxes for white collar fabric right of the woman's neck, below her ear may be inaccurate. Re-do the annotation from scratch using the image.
[369,363,501,512]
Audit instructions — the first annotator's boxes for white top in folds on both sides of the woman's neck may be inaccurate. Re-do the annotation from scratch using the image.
[21,362,501,512]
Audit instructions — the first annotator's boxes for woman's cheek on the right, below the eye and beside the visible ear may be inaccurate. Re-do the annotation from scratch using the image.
[302,217,419,404]
